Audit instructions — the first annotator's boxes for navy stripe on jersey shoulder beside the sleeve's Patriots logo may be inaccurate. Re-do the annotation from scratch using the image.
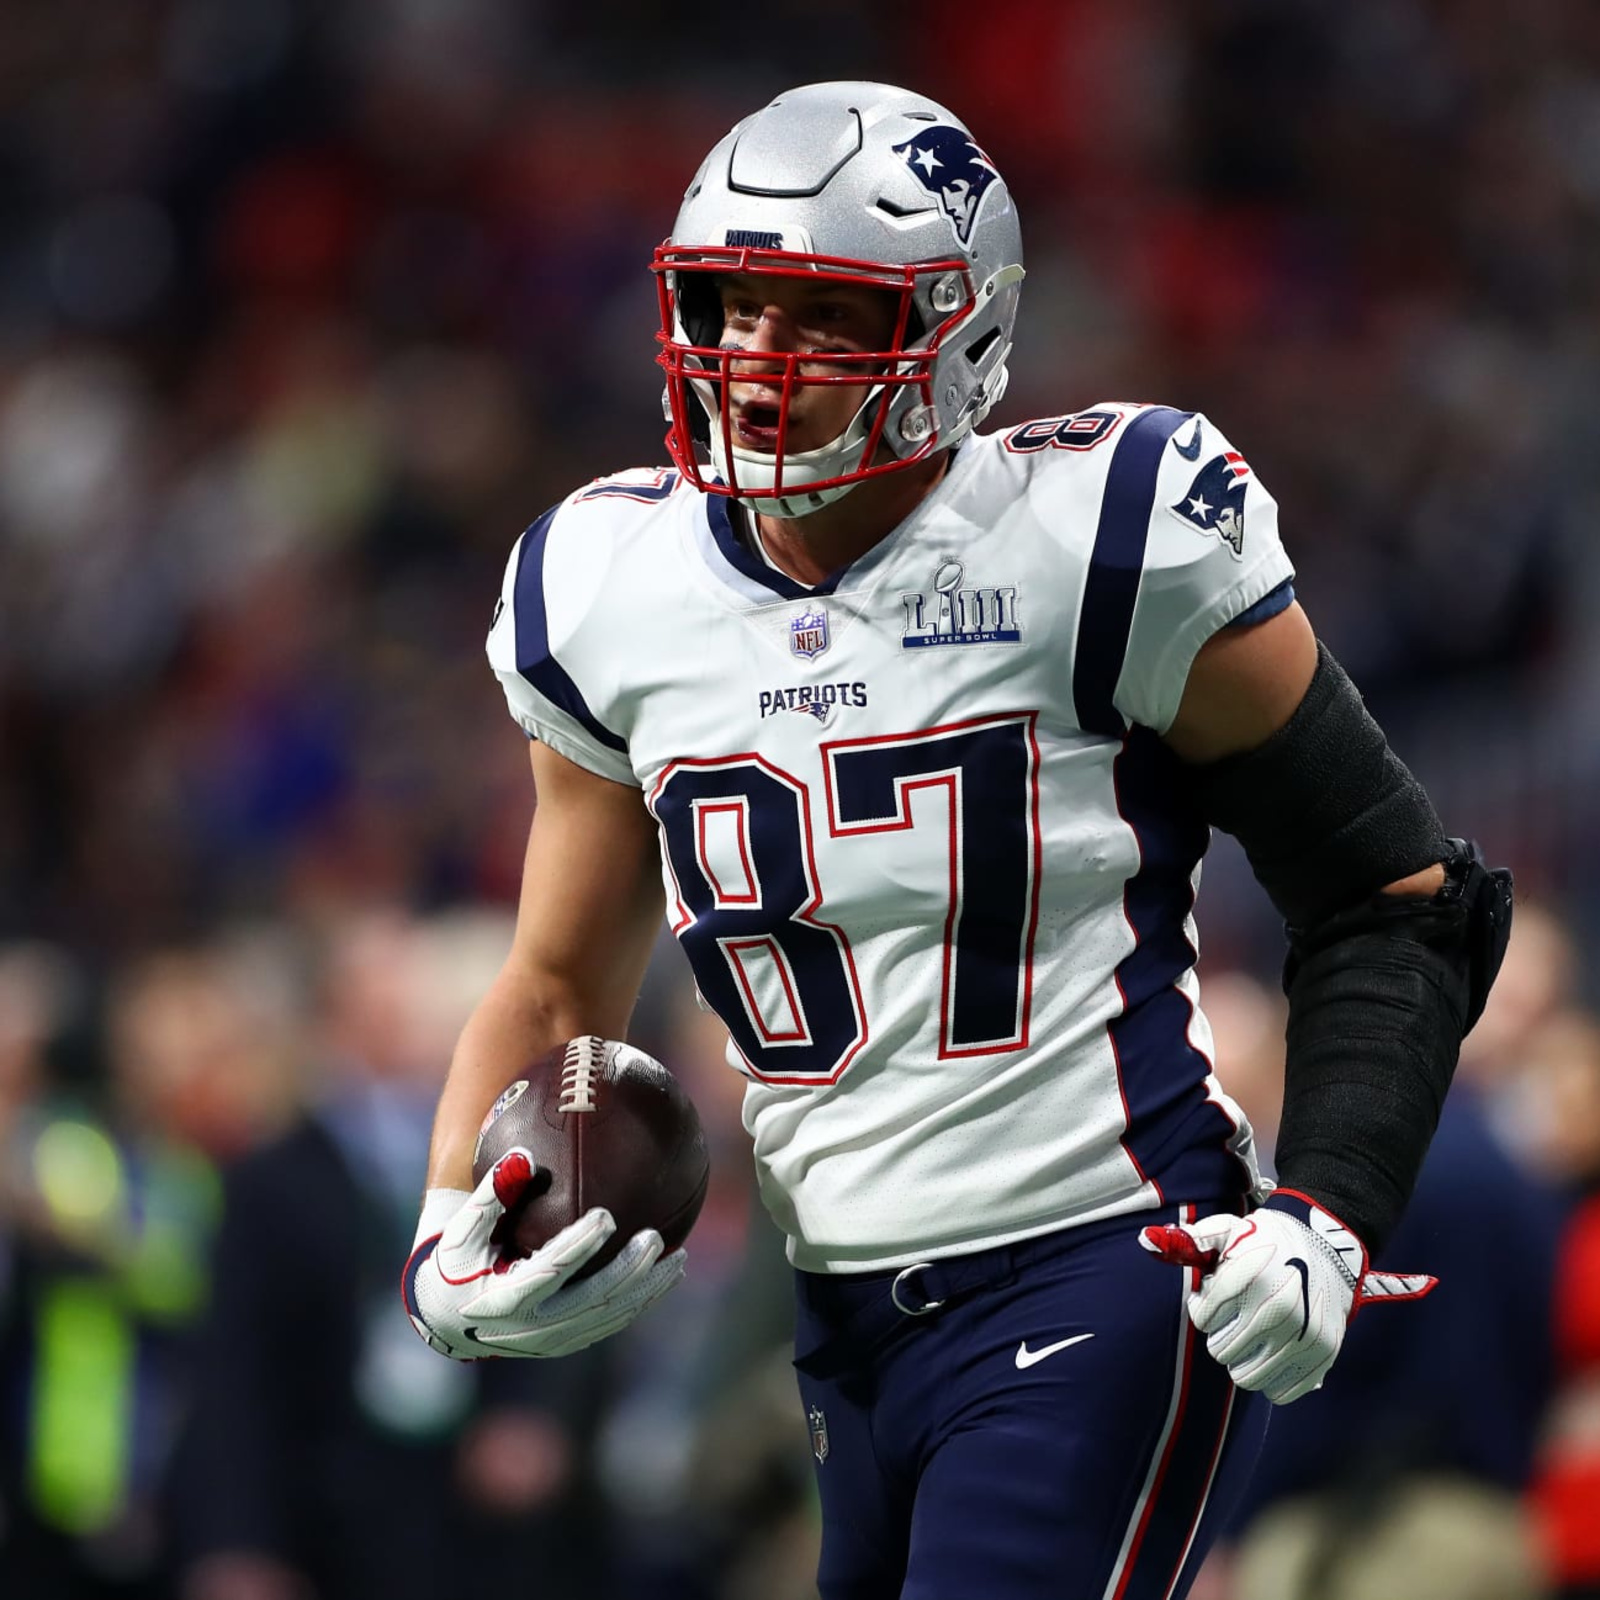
[1072,405,1194,739]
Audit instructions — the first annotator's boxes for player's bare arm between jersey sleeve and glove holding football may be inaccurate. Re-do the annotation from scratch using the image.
[427,741,662,1189]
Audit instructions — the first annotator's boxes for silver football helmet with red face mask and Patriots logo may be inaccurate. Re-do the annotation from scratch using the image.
[651,83,1022,517]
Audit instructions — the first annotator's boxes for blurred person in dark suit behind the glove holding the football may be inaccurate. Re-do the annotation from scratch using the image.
[173,912,603,1600]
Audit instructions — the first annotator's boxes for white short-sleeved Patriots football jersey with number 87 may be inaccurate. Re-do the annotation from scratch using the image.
[488,405,1293,1272]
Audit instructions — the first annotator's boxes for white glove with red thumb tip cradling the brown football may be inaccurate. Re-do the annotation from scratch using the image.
[400,1149,683,1362]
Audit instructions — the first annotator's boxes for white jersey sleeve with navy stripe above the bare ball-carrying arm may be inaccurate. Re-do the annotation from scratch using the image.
[486,502,638,786]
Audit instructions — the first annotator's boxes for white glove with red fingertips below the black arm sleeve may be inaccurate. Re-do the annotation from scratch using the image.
[1139,1189,1438,1405]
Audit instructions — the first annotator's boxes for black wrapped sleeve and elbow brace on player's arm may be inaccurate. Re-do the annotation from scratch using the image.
[1194,646,1512,1253]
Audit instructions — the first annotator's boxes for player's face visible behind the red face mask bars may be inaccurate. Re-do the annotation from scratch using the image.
[720,274,898,454]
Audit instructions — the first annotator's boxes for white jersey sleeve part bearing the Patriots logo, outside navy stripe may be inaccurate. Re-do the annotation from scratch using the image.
[1112,411,1294,733]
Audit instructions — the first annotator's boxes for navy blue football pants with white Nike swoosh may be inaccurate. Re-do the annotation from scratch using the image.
[795,1206,1269,1600]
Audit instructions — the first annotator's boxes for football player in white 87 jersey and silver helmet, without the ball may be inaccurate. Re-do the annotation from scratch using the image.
[405,83,1510,1600]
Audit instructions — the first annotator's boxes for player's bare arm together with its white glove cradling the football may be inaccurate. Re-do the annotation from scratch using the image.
[402,742,683,1360]
